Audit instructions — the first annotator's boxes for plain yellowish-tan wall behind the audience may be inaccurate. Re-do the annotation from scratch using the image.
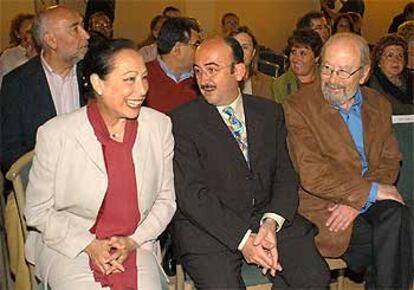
[0,0,408,50]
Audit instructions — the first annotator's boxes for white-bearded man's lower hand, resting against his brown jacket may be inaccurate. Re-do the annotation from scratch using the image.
[326,204,359,232]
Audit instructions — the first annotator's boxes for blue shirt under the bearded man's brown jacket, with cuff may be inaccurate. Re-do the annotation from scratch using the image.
[334,89,378,213]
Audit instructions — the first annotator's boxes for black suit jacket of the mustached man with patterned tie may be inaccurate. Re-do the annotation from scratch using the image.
[171,96,298,254]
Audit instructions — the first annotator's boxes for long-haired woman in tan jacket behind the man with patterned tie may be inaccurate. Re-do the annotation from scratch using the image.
[232,26,273,100]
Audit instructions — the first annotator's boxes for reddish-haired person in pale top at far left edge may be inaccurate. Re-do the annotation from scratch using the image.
[0,14,34,84]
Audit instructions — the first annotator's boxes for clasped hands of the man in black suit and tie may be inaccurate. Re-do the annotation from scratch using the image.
[241,219,282,276]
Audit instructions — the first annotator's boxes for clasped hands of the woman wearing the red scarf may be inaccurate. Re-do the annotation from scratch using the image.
[85,236,138,275]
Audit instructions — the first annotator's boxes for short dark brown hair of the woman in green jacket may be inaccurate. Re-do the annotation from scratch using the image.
[285,29,323,58]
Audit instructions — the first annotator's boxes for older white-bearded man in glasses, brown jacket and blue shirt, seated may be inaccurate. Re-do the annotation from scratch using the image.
[284,33,413,289]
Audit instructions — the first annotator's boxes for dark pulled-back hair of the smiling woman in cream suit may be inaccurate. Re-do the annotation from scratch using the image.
[83,38,137,99]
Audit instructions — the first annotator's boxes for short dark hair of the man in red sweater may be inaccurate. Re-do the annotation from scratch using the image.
[157,17,201,55]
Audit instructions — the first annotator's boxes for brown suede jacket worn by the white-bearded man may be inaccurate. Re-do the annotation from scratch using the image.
[283,82,401,257]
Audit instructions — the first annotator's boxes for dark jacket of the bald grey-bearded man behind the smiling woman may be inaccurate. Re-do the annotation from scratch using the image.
[0,56,85,171]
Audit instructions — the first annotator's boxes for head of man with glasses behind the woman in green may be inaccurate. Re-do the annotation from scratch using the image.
[296,11,331,43]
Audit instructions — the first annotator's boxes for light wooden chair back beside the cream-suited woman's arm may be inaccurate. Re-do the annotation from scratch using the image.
[6,150,34,240]
